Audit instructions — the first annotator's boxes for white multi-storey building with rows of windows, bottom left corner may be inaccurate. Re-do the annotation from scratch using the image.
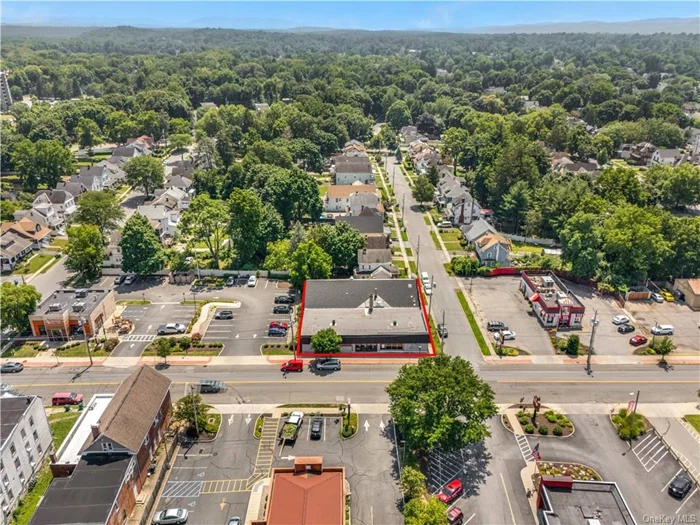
[0,393,53,512]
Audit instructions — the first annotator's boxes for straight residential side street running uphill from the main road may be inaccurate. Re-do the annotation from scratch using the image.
[388,157,481,362]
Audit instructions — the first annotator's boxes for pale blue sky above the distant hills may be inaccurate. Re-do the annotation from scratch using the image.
[0,0,700,30]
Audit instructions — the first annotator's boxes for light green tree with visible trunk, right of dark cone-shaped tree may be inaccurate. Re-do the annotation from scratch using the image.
[180,193,229,269]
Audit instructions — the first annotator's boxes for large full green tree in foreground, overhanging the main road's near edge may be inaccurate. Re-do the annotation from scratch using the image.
[386,355,498,451]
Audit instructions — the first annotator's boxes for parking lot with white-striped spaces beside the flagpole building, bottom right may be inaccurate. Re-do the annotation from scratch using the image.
[527,415,700,523]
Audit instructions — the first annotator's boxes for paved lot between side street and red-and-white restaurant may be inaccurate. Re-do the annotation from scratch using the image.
[465,276,554,355]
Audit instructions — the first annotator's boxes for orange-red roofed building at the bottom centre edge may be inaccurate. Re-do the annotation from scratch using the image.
[251,457,349,525]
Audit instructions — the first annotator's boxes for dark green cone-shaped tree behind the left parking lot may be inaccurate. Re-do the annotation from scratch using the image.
[119,213,165,275]
